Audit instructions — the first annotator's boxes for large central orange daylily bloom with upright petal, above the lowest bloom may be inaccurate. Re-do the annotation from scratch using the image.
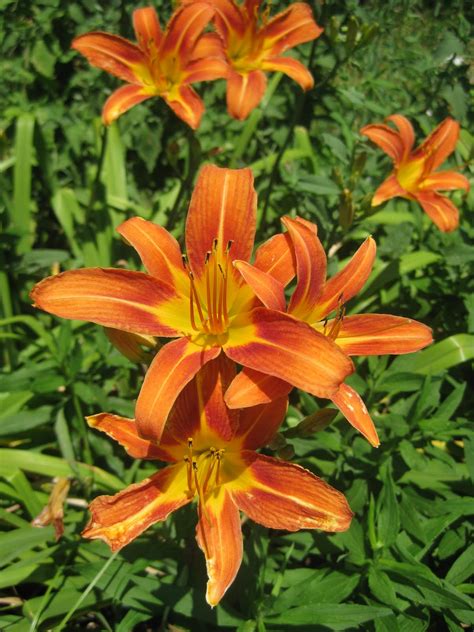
[32,165,353,441]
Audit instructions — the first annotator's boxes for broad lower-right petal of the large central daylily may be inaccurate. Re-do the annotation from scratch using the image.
[223,308,353,397]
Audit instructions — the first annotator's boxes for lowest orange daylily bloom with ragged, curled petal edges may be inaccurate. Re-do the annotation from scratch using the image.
[83,355,352,606]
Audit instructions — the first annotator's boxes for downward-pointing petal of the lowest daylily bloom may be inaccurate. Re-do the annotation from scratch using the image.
[196,487,243,606]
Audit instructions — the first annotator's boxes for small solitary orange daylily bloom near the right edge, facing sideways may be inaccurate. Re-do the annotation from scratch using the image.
[360,114,469,233]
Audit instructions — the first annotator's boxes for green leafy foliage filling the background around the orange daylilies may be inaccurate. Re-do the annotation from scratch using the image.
[0,0,474,632]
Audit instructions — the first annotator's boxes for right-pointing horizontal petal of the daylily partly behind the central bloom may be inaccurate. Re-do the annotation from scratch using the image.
[336,314,433,355]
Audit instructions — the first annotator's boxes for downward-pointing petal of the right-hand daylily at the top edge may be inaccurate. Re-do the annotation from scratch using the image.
[227,70,267,121]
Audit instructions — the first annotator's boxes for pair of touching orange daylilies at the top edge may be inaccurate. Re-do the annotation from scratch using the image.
[72,0,322,129]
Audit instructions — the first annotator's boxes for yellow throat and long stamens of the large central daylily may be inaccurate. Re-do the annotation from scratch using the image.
[183,239,232,335]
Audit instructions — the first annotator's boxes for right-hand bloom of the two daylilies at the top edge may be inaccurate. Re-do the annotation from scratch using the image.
[198,0,323,120]
